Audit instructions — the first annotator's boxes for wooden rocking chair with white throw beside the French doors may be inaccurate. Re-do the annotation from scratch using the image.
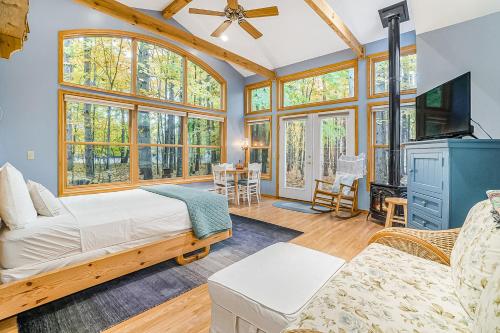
[311,154,366,218]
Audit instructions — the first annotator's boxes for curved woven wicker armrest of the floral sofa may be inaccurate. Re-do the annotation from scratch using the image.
[369,228,460,266]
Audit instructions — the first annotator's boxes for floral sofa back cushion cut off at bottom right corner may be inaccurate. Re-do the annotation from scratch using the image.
[474,267,500,333]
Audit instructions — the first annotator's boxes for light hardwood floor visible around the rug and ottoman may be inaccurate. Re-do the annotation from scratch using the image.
[0,199,383,333]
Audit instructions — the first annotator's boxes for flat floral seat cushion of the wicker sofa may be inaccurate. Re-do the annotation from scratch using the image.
[288,244,472,333]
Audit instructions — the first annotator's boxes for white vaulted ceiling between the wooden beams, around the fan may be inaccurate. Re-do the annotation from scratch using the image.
[119,0,500,76]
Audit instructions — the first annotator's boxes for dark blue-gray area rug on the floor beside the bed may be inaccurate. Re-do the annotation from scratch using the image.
[17,215,302,333]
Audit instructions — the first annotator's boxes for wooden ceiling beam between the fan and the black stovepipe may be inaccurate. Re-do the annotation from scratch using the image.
[304,0,365,58]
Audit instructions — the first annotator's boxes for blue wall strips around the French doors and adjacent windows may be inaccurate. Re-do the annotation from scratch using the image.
[245,31,418,209]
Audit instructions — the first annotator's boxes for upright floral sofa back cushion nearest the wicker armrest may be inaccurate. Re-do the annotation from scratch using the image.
[450,200,500,318]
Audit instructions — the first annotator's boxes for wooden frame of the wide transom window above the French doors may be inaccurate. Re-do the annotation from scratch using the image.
[276,59,358,111]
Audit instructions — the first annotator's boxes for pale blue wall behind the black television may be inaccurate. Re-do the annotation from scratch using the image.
[417,13,500,139]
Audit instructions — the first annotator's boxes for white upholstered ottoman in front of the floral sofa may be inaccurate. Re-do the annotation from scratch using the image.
[208,243,344,333]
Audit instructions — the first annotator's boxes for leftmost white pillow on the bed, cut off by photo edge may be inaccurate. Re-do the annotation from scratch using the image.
[0,163,37,229]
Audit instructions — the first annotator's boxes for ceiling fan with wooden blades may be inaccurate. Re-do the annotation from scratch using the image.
[189,0,279,39]
